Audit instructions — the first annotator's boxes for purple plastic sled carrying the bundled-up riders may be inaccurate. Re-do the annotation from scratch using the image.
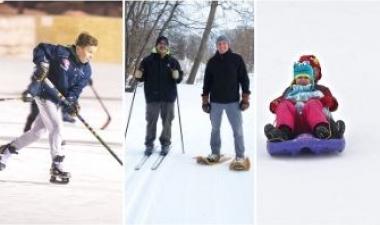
[267,133,346,156]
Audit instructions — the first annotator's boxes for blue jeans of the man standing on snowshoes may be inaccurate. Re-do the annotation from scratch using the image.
[210,102,245,157]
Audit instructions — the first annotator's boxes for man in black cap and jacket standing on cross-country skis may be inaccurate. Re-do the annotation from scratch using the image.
[135,36,183,156]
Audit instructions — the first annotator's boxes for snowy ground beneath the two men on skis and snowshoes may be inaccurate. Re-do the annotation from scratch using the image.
[124,79,255,224]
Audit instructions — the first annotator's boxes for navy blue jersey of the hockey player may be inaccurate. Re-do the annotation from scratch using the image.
[33,43,91,103]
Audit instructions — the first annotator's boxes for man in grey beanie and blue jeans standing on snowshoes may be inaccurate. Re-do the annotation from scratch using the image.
[197,35,251,170]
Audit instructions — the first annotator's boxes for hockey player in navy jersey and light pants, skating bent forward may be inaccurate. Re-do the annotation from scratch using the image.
[0,32,98,183]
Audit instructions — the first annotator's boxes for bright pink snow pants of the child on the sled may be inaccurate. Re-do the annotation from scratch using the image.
[276,99,328,135]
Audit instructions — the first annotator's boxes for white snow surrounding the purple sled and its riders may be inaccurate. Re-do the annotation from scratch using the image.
[255,1,380,225]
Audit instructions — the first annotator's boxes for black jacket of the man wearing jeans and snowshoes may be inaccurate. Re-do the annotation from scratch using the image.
[202,50,251,103]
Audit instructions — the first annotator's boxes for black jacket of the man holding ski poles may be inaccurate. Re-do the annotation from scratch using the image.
[138,53,183,103]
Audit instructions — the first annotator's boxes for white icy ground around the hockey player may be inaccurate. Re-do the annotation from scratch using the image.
[0,58,123,224]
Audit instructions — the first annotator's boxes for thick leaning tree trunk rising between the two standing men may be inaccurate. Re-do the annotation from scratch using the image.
[186,1,218,84]
